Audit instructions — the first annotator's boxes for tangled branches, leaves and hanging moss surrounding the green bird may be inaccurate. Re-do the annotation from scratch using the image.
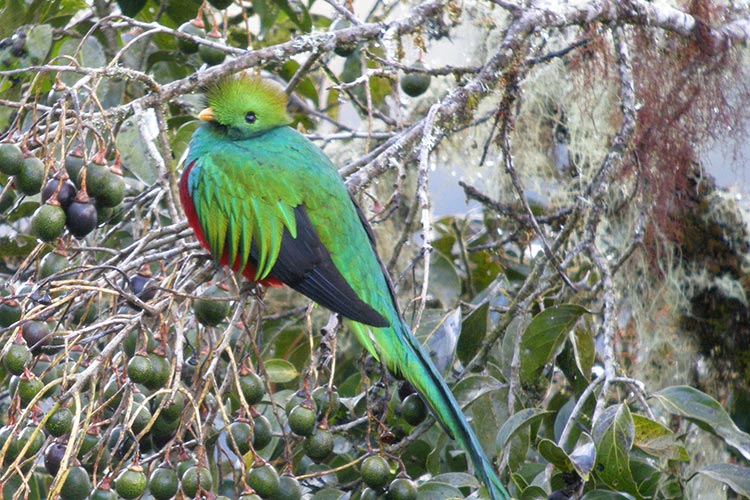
[0,0,750,500]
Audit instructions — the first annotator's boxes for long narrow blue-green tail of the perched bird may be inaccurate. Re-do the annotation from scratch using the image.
[353,319,510,500]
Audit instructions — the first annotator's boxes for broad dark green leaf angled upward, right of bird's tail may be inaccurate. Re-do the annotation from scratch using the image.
[521,304,586,384]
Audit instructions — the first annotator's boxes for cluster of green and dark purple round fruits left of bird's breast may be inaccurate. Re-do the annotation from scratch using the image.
[0,143,125,242]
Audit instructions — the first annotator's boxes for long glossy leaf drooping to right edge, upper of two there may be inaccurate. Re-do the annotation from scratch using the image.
[653,385,750,460]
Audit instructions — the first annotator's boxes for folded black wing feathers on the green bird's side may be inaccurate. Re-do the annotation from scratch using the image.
[250,205,390,327]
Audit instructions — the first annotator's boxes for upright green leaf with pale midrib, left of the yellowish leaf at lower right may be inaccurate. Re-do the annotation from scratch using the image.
[592,404,640,498]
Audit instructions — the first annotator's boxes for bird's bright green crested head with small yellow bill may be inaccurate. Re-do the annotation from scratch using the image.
[198,73,292,139]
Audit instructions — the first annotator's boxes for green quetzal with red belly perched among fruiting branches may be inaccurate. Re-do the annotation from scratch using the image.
[180,73,509,500]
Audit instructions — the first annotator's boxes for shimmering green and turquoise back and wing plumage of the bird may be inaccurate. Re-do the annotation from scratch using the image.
[186,126,398,348]
